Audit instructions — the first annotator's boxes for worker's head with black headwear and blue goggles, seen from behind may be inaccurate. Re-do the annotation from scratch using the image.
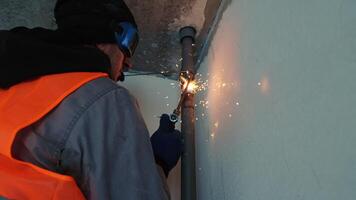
[55,0,138,80]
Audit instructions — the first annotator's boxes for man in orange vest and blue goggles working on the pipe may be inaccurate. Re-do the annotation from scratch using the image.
[0,0,180,200]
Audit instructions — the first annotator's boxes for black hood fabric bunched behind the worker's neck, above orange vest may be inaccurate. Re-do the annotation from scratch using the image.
[0,27,110,89]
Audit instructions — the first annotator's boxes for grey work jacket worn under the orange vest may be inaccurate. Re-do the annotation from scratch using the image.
[12,78,169,200]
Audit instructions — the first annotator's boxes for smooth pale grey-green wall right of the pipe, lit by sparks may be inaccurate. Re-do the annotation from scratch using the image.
[196,0,356,200]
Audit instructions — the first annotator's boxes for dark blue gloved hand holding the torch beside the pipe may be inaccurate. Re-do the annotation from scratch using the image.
[151,114,183,176]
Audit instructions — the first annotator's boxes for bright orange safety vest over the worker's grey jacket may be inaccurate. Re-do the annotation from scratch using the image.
[0,72,107,200]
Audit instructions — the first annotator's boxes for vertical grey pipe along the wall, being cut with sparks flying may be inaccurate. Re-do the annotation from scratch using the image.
[180,27,196,200]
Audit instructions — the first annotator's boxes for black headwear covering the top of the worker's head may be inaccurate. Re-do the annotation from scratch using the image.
[54,0,137,44]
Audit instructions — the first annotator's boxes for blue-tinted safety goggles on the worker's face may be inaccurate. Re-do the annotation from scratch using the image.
[115,22,139,57]
